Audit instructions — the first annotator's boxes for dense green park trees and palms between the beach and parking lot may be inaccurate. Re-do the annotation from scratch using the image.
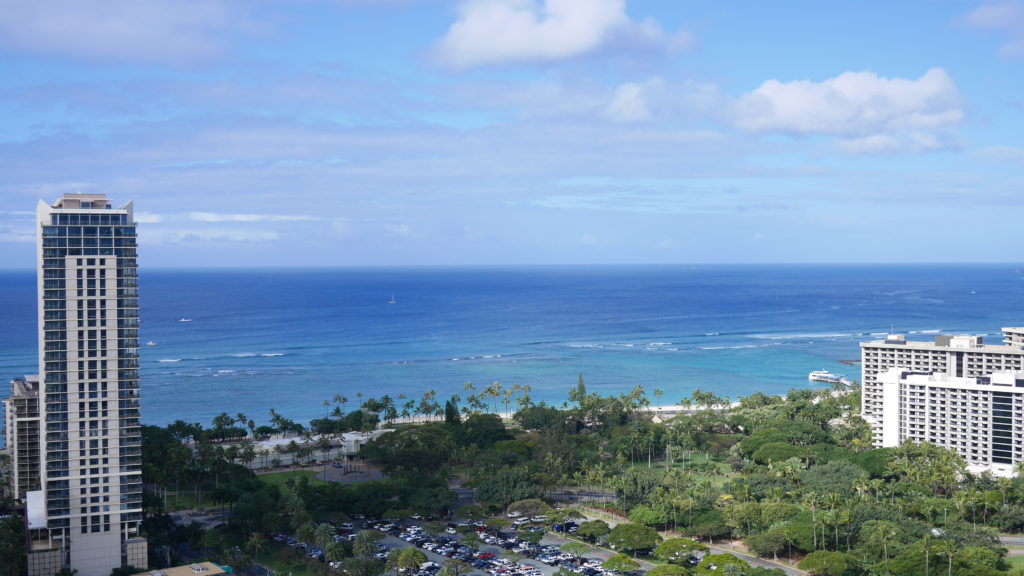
[2,377,1024,576]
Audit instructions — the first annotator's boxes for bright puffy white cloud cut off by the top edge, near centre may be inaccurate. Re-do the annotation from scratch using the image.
[435,0,694,69]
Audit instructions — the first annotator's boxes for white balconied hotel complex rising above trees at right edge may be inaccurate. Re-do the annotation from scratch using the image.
[860,328,1024,471]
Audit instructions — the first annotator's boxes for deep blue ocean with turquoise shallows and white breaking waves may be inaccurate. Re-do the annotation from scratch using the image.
[0,264,1024,424]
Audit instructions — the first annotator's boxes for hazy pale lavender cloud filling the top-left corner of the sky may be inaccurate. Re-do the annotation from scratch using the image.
[0,0,260,64]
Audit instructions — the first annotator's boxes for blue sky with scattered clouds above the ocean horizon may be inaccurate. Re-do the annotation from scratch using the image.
[0,0,1024,269]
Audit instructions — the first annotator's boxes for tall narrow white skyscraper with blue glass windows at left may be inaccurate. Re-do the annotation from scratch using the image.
[15,194,147,576]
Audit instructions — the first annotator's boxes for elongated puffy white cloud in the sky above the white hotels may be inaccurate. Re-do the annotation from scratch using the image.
[734,68,964,152]
